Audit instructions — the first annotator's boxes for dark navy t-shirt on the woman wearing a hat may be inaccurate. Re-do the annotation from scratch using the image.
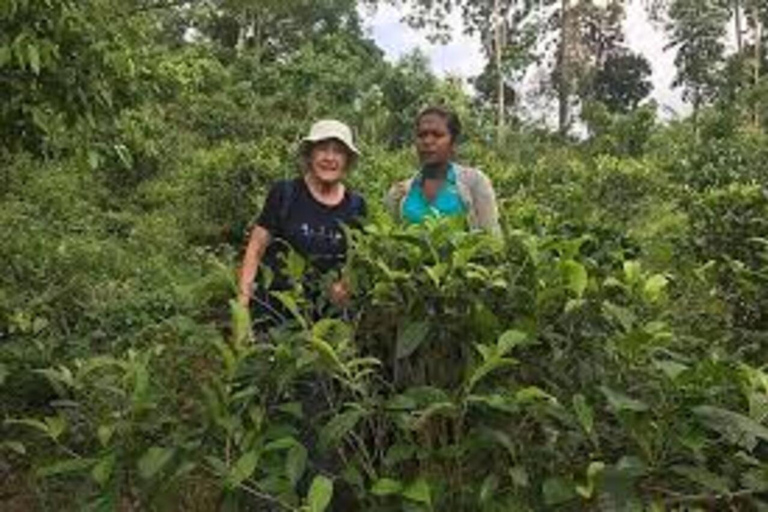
[256,178,366,289]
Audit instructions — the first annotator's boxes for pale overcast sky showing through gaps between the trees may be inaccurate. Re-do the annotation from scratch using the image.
[364,1,687,122]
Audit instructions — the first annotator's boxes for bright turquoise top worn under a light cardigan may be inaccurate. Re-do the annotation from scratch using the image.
[403,163,467,224]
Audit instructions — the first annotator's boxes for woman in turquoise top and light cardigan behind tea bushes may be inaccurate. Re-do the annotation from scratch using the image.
[386,107,501,235]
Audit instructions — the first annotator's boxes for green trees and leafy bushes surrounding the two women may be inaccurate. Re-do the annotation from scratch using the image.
[0,0,768,511]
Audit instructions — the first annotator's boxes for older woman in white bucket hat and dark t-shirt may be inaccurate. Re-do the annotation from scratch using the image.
[239,119,366,317]
